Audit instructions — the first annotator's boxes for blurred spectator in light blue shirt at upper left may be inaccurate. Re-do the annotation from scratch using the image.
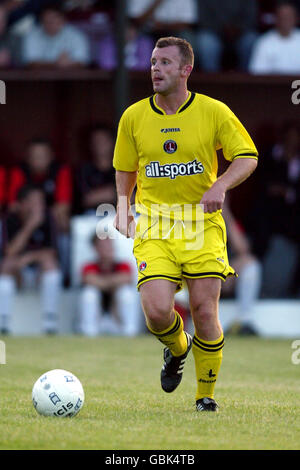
[23,4,90,69]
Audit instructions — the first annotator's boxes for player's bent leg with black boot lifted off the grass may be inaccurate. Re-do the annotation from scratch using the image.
[140,279,191,392]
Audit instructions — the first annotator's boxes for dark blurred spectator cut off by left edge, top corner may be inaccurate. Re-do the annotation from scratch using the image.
[0,5,20,69]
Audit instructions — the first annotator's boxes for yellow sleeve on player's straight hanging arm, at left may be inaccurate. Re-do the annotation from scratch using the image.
[113,110,138,171]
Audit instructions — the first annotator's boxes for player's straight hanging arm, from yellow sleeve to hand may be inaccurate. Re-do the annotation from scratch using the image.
[113,108,138,238]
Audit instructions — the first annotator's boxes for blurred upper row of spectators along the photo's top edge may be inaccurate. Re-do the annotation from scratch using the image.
[0,0,300,74]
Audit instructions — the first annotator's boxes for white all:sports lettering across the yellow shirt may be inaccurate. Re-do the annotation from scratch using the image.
[145,159,204,180]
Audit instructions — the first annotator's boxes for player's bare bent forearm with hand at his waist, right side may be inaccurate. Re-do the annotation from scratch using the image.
[200,158,257,213]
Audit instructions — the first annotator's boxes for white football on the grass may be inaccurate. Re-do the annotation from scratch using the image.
[32,369,84,417]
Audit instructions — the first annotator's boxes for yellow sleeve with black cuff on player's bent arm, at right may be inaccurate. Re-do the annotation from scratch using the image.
[216,103,258,161]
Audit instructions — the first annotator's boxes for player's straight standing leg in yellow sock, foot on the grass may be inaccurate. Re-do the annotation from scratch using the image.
[186,277,224,411]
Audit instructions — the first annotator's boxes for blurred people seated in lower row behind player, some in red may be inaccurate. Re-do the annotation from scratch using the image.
[0,117,300,335]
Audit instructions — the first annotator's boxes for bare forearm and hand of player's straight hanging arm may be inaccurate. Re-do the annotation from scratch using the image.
[114,170,137,238]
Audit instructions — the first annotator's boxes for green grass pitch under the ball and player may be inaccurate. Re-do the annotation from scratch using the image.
[0,335,300,450]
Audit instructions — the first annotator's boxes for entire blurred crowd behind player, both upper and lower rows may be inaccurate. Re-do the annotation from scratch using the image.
[0,0,300,335]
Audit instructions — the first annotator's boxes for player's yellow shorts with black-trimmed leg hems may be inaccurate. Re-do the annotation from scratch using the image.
[133,212,236,291]
